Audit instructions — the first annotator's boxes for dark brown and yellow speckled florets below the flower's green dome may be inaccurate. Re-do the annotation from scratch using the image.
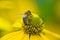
[23,24,42,35]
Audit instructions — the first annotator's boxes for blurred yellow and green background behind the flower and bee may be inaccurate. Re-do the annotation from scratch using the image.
[0,0,60,37]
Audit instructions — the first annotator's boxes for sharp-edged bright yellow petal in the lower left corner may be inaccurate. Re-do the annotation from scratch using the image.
[0,31,24,40]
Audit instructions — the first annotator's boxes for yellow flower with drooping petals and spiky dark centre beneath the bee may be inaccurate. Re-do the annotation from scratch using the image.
[0,10,60,40]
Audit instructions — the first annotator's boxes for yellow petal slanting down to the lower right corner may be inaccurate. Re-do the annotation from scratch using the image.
[43,29,60,40]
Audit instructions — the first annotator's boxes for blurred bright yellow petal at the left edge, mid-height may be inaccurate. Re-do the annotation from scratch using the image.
[0,17,12,31]
